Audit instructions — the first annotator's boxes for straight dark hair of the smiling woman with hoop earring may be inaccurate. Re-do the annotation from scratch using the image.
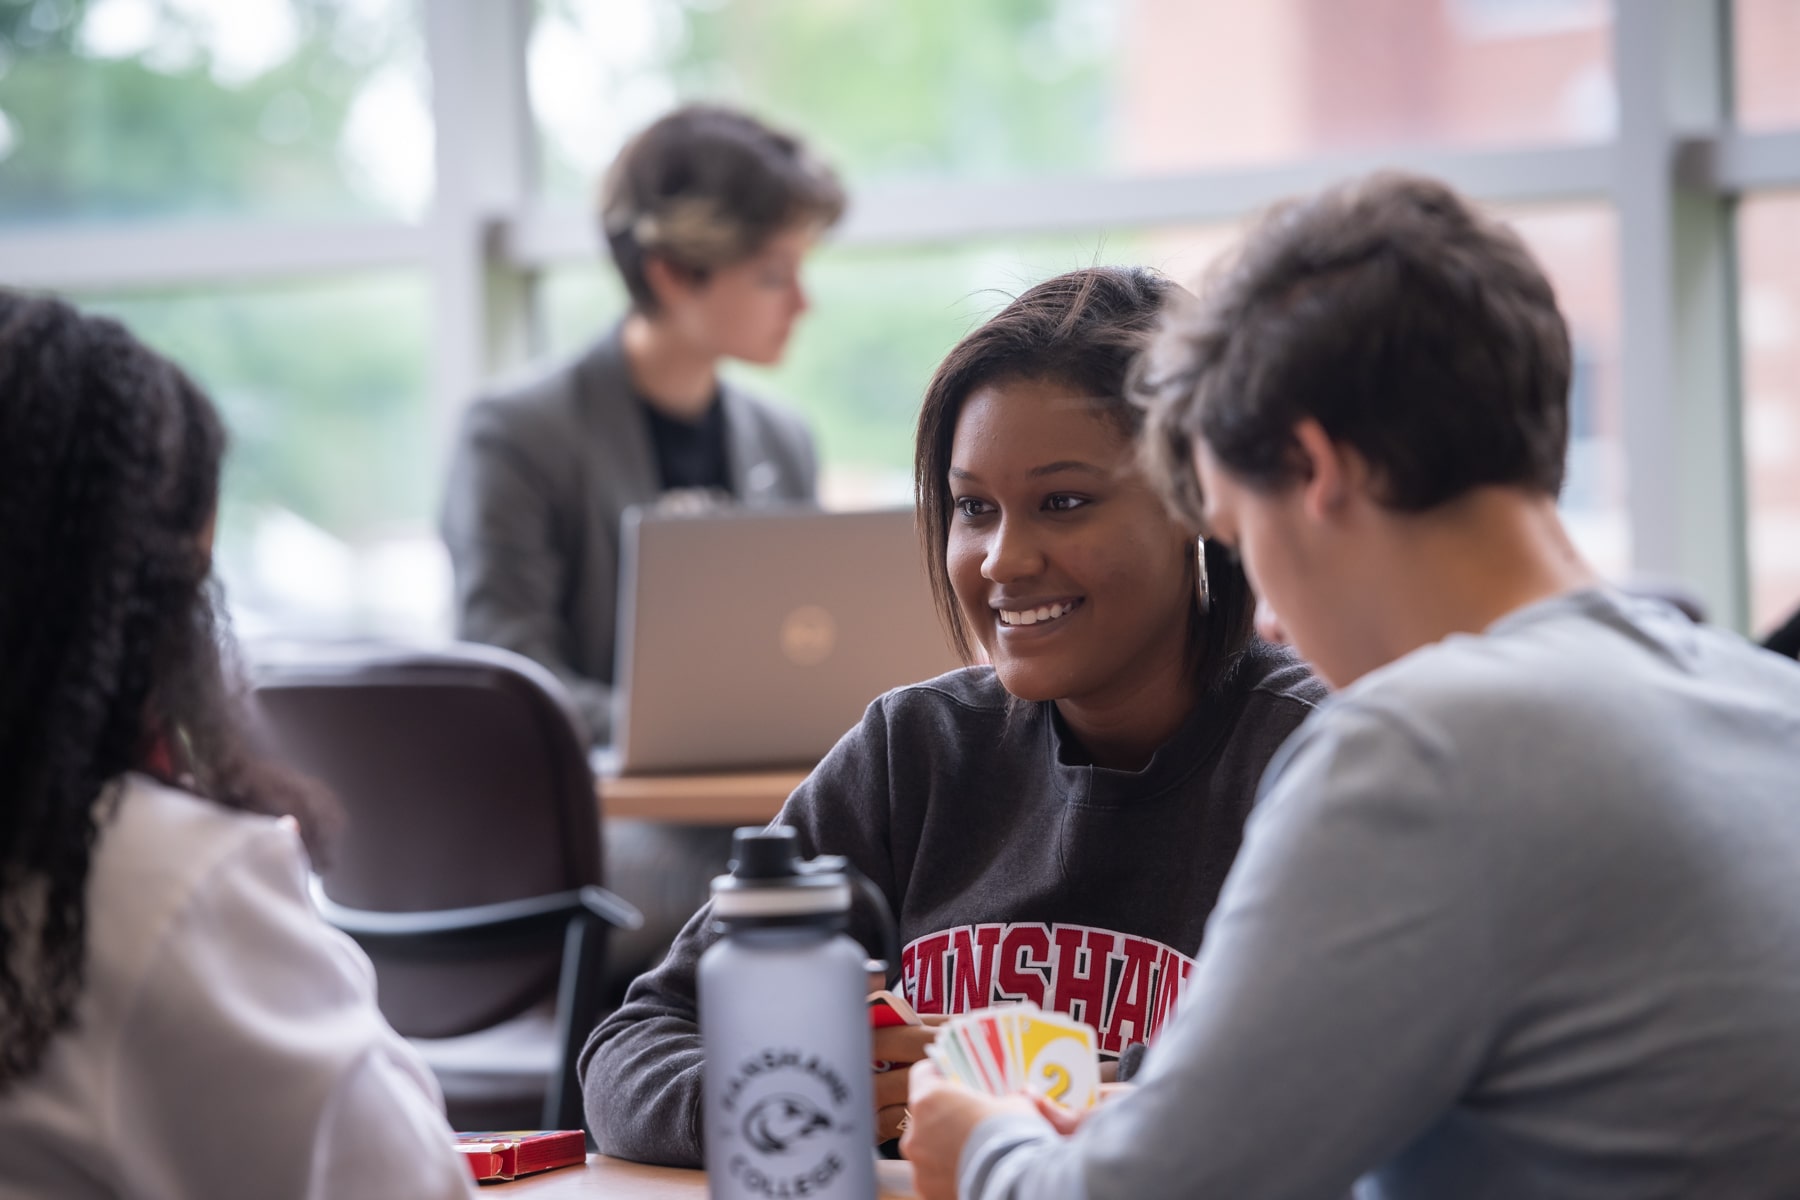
[913,266,1256,694]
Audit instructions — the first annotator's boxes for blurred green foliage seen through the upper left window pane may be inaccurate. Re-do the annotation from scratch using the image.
[0,0,408,221]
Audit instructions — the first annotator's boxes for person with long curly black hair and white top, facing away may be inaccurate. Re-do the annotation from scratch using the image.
[0,291,472,1196]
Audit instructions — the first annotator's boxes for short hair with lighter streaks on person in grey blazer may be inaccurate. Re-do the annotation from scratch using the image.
[599,104,844,313]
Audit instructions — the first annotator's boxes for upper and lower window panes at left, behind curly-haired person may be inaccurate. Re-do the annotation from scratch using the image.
[0,0,448,635]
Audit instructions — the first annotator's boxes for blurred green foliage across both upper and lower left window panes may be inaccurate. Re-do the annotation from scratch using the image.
[0,0,437,549]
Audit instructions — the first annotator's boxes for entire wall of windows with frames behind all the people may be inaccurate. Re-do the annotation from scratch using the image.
[0,0,1800,633]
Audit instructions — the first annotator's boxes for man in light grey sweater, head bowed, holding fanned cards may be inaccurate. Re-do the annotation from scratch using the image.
[904,175,1800,1200]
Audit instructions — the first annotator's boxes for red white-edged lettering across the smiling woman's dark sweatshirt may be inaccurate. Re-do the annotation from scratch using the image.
[900,921,1193,1054]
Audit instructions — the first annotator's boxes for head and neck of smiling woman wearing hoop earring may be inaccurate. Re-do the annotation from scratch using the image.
[914,268,1255,766]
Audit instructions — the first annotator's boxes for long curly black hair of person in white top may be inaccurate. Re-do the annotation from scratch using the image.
[0,291,331,1085]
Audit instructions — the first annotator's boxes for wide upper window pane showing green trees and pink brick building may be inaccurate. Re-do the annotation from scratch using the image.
[531,0,1615,205]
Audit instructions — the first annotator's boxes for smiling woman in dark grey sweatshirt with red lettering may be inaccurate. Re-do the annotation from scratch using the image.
[581,268,1323,1166]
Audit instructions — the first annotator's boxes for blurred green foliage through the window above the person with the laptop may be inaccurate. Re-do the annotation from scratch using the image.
[670,0,1114,182]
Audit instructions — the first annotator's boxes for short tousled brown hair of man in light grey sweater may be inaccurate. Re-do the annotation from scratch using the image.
[1132,173,1570,515]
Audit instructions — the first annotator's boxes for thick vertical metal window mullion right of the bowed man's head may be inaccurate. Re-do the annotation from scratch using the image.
[1613,0,1748,630]
